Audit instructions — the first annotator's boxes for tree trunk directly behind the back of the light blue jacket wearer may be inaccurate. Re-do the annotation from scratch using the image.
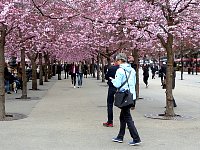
[132,49,140,99]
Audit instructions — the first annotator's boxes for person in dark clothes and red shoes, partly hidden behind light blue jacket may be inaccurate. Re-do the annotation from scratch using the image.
[103,63,119,127]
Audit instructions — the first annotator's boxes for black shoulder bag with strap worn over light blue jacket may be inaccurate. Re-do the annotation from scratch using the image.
[114,70,134,109]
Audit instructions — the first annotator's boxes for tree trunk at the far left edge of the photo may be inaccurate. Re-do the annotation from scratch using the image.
[0,25,6,120]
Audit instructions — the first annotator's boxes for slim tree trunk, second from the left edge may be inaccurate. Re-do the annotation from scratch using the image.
[21,47,28,99]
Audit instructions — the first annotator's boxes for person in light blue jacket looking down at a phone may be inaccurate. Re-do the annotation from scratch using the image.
[110,53,141,146]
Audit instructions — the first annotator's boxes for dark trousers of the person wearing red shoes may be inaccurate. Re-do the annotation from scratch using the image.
[107,87,117,123]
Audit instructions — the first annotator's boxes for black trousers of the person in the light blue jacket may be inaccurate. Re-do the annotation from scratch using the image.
[117,106,140,142]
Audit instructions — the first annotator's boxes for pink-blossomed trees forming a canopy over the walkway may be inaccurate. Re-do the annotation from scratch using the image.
[0,0,200,118]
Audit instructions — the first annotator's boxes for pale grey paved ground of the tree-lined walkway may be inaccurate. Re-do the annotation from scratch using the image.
[0,70,200,150]
